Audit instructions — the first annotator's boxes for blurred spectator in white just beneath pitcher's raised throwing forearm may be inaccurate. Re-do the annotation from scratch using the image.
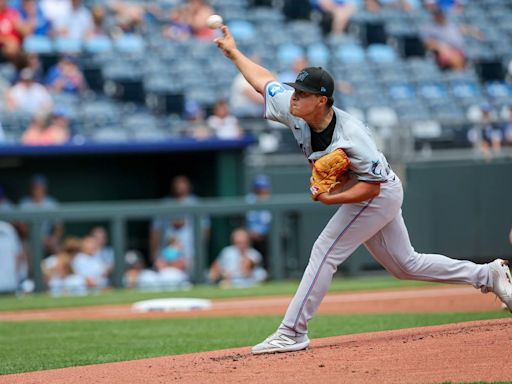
[229,73,263,118]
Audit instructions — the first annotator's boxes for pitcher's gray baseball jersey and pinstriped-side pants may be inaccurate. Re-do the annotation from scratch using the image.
[265,82,490,336]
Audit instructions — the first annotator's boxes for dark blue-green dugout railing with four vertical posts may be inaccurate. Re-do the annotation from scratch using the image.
[0,194,335,291]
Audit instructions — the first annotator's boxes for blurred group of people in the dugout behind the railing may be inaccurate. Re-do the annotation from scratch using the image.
[0,174,272,296]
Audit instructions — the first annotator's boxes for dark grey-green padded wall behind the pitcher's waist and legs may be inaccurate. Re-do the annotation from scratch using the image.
[248,158,512,273]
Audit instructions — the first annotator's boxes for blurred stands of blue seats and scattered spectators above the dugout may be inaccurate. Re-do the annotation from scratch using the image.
[0,0,512,154]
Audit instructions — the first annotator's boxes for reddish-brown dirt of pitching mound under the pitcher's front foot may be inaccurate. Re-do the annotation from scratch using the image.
[0,319,512,384]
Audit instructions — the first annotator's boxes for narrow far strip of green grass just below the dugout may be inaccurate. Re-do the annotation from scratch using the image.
[0,276,432,311]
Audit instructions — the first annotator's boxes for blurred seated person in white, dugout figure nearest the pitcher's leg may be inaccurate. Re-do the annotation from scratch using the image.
[208,228,267,288]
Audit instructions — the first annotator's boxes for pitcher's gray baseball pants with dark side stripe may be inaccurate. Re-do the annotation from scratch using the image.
[279,177,489,336]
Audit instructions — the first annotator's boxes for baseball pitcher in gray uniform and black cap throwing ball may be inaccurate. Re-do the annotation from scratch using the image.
[215,26,512,354]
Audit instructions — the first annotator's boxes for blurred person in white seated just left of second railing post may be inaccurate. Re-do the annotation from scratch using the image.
[71,236,108,289]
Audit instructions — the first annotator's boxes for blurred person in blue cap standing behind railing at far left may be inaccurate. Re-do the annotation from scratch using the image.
[19,175,64,255]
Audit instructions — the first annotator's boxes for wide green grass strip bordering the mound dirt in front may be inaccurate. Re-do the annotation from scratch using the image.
[0,312,507,374]
